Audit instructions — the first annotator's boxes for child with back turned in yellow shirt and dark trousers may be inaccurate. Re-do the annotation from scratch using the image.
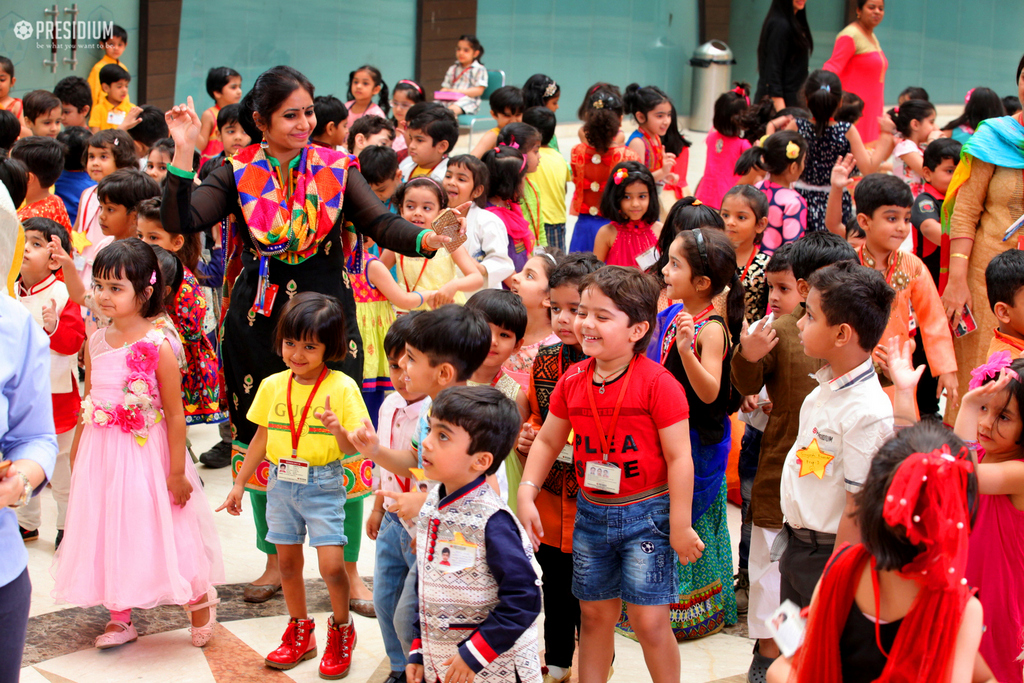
[522,109,572,251]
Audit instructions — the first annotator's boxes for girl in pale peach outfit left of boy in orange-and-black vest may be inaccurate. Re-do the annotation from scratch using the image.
[503,248,561,390]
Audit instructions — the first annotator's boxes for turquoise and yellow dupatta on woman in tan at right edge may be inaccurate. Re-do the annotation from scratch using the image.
[939,116,1024,294]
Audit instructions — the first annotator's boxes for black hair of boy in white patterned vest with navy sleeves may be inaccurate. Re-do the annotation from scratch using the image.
[430,386,522,475]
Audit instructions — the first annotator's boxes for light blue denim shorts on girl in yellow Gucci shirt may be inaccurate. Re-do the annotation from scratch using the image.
[266,461,348,548]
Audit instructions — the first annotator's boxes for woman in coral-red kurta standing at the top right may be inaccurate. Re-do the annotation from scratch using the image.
[822,0,889,144]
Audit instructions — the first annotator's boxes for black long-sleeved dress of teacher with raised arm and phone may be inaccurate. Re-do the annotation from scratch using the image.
[161,166,422,444]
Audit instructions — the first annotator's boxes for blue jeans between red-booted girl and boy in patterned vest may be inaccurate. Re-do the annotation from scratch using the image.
[374,512,416,671]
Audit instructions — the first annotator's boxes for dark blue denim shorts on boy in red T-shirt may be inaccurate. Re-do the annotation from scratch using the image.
[572,495,679,605]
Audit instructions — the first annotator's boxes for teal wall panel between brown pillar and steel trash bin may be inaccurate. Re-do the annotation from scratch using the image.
[476,0,698,121]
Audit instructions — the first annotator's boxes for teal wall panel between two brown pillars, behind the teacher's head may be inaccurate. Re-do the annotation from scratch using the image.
[175,0,415,112]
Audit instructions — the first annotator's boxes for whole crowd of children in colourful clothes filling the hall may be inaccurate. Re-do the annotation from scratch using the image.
[6,18,1024,683]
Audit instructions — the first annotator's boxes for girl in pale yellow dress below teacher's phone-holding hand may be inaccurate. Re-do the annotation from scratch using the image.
[381,178,483,310]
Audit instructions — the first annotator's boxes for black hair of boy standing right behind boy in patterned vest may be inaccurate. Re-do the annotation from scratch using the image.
[406,303,490,382]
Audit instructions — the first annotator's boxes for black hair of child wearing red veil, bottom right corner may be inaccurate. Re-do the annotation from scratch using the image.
[854,420,978,571]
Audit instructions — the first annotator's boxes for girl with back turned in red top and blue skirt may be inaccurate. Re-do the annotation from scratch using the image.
[569,90,640,251]
